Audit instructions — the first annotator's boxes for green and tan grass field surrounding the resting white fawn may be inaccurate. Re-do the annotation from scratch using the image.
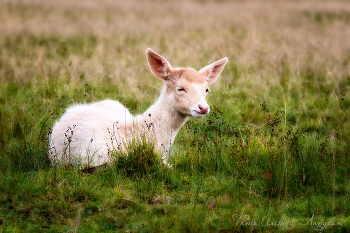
[0,0,350,232]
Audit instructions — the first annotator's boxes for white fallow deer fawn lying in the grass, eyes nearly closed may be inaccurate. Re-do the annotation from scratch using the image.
[49,49,228,166]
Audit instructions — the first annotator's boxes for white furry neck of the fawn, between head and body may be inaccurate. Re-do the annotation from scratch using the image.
[136,86,188,151]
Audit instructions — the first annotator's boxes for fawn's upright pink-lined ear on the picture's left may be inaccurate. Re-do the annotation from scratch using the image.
[146,48,172,81]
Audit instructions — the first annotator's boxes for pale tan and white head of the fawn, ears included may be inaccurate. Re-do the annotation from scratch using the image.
[146,49,228,117]
